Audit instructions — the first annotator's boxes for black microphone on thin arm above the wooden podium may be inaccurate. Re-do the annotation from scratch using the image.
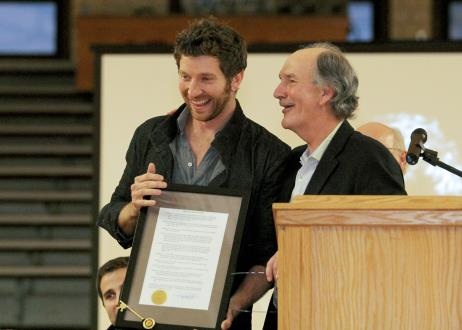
[406,128,462,177]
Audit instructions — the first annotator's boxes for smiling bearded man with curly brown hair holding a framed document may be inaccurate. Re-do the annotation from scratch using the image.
[98,19,289,330]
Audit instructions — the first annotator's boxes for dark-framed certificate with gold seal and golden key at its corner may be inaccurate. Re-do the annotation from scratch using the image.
[116,185,249,330]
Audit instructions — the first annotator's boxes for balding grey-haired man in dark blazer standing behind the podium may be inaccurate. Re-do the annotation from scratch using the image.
[264,43,406,330]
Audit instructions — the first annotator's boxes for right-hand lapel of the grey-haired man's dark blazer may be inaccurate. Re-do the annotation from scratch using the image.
[305,120,354,195]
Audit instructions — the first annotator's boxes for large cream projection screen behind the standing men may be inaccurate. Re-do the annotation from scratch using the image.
[97,48,462,329]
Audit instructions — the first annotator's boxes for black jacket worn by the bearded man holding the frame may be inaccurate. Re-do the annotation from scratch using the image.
[97,103,290,329]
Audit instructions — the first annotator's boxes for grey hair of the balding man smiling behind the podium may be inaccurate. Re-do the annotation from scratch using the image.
[305,42,359,119]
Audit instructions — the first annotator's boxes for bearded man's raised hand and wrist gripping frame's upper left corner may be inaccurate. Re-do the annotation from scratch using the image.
[118,163,167,236]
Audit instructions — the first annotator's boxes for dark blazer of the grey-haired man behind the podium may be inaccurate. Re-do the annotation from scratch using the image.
[263,121,406,330]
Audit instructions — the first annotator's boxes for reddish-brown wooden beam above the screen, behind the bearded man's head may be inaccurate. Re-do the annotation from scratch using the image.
[76,15,348,91]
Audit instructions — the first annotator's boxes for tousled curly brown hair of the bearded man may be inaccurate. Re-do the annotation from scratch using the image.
[173,17,247,81]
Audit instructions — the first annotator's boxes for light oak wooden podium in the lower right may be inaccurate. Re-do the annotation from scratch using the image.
[273,196,462,330]
